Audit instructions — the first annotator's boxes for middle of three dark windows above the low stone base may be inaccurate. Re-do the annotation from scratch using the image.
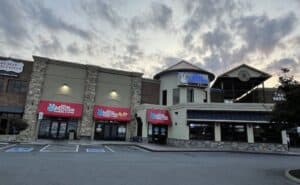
[221,123,247,142]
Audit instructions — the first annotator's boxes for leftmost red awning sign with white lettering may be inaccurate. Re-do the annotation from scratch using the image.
[38,100,82,118]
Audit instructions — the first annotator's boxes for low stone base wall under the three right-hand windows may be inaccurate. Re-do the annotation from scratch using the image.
[168,139,288,152]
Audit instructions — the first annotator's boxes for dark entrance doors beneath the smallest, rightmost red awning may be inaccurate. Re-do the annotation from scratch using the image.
[152,125,168,144]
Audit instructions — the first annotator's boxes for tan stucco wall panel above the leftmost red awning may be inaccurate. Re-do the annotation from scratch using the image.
[41,64,86,103]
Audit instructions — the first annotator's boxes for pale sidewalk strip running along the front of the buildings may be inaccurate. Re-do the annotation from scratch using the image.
[18,139,300,156]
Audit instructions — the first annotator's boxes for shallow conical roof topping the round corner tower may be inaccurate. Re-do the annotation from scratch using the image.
[154,60,215,81]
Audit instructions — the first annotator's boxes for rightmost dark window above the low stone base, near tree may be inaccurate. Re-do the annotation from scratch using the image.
[253,124,281,143]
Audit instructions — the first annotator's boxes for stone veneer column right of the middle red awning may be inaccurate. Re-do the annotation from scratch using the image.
[126,77,142,140]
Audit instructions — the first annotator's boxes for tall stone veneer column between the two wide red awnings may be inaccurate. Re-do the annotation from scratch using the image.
[80,67,98,138]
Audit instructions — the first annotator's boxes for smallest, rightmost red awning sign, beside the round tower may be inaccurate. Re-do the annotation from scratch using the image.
[147,109,171,125]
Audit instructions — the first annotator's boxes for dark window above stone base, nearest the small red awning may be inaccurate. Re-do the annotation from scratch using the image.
[189,123,215,140]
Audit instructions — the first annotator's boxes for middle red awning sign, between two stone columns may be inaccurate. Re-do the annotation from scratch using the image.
[94,105,130,121]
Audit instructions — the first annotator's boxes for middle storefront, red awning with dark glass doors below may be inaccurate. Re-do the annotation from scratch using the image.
[94,105,130,141]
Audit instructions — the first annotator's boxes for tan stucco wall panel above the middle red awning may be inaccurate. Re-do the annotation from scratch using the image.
[95,72,131,107]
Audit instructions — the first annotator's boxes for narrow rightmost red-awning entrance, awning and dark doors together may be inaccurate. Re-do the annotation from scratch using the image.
[147,109,171,144]
